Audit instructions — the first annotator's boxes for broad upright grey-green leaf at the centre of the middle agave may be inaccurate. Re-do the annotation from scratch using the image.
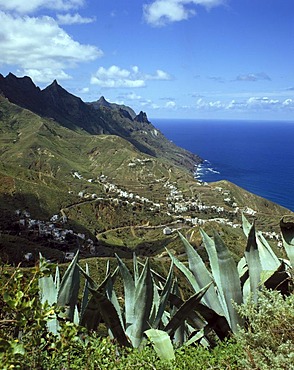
[126,259,154,348]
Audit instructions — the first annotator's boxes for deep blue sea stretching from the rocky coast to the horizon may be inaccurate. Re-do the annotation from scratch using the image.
[152,119,294,211]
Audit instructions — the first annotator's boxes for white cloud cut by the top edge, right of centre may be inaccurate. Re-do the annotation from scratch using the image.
[143,0,225,26]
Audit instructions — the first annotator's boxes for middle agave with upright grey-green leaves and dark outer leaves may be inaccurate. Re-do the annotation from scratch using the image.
[81,256,209,348]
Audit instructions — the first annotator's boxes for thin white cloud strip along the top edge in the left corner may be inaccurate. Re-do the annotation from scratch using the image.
[0,0,85,14]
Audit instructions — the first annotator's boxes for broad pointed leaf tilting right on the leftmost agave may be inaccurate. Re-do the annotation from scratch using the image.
[57,252,80,321]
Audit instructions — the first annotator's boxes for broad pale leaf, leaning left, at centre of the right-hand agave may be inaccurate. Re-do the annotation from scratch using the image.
[201,230,243,333]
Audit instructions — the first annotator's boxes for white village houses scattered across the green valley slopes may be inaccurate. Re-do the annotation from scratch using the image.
[10,165,282,261]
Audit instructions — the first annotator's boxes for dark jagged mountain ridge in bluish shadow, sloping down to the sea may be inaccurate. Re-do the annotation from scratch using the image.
[0,74,201,171]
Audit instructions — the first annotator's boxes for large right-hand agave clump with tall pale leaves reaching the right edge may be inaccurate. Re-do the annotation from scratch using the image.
[169,216,294,339]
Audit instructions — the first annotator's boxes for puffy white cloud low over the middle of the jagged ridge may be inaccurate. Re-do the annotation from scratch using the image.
[91,65,170,88]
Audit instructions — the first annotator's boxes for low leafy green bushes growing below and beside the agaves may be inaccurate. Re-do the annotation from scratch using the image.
[0,269,294,370]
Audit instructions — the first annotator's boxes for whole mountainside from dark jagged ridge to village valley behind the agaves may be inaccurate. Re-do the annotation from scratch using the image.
[0,73,291,264]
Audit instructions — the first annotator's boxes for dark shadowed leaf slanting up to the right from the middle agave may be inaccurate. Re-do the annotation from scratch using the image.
[164,283,212,337]
